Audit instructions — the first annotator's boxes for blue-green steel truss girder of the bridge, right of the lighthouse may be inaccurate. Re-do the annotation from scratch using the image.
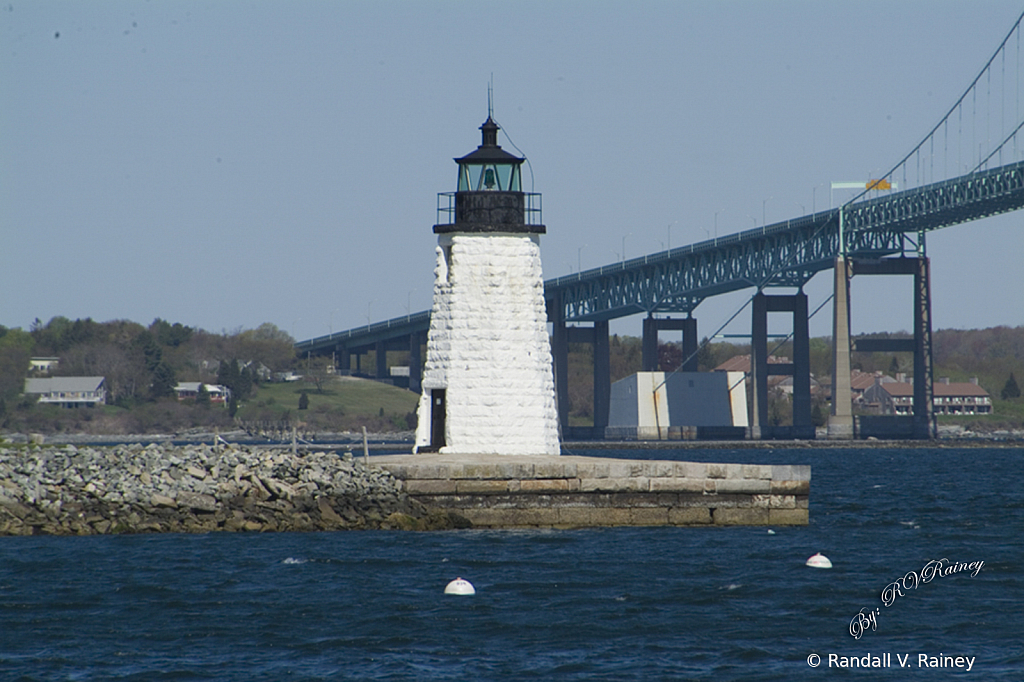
[545,157,1024,322]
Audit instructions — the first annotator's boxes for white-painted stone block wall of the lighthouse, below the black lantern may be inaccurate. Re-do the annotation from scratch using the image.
[417,235,559,455]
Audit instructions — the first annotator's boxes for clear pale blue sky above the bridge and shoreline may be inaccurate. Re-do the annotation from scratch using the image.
[0,0,1024,340]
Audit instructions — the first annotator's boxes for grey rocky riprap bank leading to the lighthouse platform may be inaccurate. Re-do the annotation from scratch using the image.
[0,444,466,536]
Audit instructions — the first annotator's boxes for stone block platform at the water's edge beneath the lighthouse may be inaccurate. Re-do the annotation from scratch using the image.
[374,454,811,528]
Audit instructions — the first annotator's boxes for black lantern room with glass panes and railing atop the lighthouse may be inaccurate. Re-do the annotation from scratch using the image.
[434,116,545,235]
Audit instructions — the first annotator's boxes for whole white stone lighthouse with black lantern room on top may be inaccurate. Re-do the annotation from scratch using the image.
[416,116,560,455]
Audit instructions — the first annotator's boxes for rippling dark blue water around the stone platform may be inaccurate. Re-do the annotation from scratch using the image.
[0,449,1024,682]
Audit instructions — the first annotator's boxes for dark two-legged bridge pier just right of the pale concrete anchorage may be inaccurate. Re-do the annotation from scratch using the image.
[751,292,814,440]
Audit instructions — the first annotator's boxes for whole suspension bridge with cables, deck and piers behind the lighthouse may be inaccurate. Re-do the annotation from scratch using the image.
[296,14,1024,437]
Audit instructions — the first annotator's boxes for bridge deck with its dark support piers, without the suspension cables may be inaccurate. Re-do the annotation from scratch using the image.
[296,157,1024,437]
